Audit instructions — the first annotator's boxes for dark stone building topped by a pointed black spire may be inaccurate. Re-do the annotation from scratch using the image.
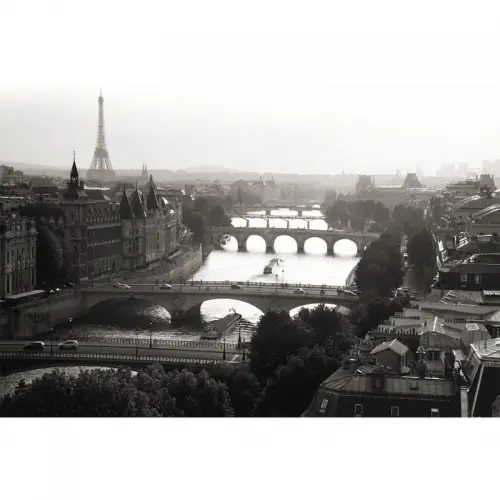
[59,156,122,280]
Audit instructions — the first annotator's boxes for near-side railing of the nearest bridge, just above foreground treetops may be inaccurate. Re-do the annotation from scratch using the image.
[0,351,242,365]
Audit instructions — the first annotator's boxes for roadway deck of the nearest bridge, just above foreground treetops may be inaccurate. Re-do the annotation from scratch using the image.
[0,338,247,364]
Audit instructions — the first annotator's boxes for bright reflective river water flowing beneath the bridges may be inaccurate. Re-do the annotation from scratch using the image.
[0,210,359,395]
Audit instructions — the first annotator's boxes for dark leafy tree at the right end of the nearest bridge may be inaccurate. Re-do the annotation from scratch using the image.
[250,311,311,382]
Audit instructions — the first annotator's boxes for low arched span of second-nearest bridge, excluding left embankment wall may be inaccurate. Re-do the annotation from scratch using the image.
[80,282,359,317]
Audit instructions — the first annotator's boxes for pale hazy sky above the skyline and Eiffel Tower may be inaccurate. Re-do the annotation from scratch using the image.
[0,0,500,173]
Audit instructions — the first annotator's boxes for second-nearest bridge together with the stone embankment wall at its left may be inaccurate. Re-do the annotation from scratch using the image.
[7,281,359,339]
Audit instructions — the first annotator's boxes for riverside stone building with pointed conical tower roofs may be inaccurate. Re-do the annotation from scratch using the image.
[119,175,179,269]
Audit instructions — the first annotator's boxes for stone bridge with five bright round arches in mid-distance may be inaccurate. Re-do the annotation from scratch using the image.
[212,226,380,255]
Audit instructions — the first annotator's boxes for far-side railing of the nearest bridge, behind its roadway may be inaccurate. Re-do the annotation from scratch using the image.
[44,335,239,352]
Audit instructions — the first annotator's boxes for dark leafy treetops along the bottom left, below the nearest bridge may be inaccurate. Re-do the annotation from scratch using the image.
[0,365,234,417]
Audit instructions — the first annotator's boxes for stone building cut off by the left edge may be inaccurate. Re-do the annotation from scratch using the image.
[0,212,37,299]
